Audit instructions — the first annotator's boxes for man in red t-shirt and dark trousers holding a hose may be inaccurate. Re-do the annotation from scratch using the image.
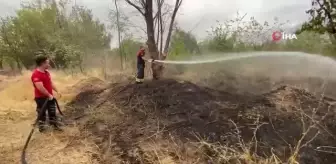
[31,56,62,132]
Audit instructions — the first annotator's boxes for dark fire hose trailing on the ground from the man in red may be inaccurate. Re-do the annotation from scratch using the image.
[21,99,63,164]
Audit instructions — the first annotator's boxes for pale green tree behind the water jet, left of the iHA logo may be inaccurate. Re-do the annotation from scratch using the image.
[199,13,292,52]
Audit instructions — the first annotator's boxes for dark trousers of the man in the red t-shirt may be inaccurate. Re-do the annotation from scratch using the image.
[35,98,57,126]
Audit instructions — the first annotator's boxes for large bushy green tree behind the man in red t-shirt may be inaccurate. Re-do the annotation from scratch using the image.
[0,0,111,70]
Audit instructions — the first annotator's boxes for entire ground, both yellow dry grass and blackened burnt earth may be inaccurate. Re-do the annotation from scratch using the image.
[0,69,336,164]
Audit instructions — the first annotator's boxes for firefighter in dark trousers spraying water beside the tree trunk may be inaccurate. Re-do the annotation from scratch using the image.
[135,46,154,84]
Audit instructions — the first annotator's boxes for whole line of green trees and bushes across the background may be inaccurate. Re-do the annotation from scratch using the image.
[0,0,336,75]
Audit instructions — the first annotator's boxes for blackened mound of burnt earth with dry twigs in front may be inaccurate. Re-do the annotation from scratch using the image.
[64,80,336,164]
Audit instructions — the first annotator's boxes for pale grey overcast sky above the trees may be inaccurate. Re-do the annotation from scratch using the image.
[0,0,311,46]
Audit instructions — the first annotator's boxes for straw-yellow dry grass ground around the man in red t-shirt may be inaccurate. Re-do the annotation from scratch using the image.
[0,71,100,164]
